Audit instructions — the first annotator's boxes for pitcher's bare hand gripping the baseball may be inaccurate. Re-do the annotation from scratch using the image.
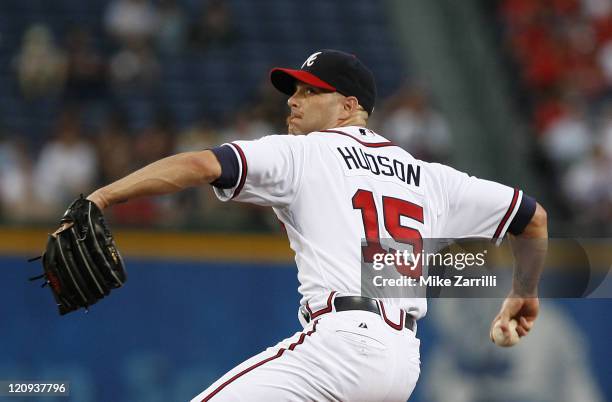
[489,293,540,339]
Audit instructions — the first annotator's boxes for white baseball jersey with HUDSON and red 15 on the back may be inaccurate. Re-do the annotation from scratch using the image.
[214,127,522,319]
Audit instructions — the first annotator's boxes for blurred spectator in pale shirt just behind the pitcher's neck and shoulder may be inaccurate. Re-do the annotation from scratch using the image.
[381,86,451,162]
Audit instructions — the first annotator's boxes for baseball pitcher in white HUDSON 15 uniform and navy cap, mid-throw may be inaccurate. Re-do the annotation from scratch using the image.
[35,50,547,402]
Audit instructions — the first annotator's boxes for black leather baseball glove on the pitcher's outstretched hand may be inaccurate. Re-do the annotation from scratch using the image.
[30,195,126,315]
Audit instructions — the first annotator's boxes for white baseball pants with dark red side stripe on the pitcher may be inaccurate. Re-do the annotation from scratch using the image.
[191,310,420,402]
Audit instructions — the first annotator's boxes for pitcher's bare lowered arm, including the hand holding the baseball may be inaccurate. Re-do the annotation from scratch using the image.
[490,204,548,346]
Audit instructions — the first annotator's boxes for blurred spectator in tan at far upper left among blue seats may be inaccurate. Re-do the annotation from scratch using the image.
[15,25,66,99]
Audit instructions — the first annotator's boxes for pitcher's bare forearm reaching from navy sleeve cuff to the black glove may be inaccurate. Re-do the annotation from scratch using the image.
[87,150,221,209]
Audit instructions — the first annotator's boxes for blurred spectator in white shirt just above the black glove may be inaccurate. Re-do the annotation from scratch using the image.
[34,111,97,214]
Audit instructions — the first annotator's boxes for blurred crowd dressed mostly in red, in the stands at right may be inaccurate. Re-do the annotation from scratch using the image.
[498,0,612,235]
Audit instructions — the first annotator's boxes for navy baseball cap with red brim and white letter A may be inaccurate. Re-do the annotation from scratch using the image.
[270,49,376,114]
